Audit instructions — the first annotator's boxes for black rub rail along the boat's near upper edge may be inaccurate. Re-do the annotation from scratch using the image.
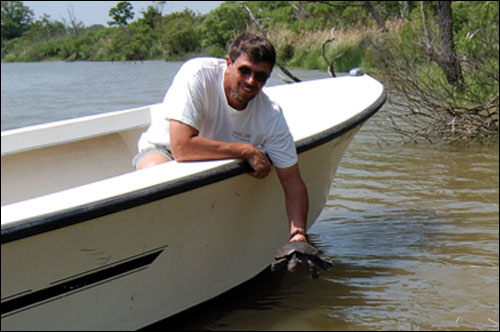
[1,87,387,244]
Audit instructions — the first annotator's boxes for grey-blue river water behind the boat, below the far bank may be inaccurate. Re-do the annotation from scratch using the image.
[1,61,328,131]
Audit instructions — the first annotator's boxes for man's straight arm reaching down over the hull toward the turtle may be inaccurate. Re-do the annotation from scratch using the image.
[276,164,309,242]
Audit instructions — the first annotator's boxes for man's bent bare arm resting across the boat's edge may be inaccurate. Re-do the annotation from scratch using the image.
[170,120,271,178]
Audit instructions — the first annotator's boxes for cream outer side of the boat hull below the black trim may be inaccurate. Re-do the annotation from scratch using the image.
[2,128,358,330]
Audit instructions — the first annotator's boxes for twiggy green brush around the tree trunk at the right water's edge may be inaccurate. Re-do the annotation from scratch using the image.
[370,2,499,142]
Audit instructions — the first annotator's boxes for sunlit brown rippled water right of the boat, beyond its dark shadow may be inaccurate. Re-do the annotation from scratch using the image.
[315,124,498,330]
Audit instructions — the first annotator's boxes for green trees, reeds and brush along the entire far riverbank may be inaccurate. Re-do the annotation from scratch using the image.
[2,1,499,141]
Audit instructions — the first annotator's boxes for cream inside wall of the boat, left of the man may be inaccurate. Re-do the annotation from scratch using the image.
[1,107,149,206]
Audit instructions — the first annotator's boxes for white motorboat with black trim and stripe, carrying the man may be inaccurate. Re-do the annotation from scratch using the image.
[1,75,386,330]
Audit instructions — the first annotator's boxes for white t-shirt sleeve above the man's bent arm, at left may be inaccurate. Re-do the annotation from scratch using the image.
[163,62,206,131]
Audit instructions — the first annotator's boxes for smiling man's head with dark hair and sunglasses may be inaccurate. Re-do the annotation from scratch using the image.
[224,33,276,109]
